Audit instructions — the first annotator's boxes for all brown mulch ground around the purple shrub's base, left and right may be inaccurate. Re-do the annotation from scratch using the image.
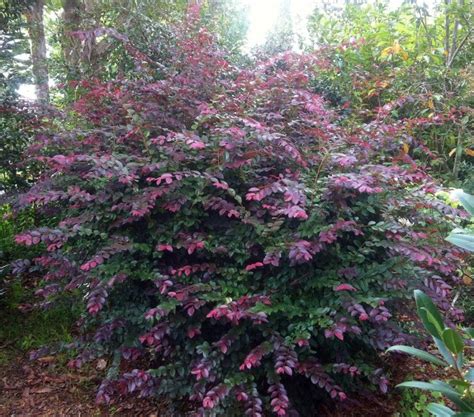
[0,346,452,417]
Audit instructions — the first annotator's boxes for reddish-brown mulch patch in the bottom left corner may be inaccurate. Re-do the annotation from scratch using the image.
[0,354,165,417]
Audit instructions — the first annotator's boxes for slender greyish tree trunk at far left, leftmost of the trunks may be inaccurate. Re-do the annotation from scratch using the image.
[26,0,49,104]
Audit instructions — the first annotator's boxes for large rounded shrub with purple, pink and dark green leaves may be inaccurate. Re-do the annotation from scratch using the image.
[12,11,463,417]
